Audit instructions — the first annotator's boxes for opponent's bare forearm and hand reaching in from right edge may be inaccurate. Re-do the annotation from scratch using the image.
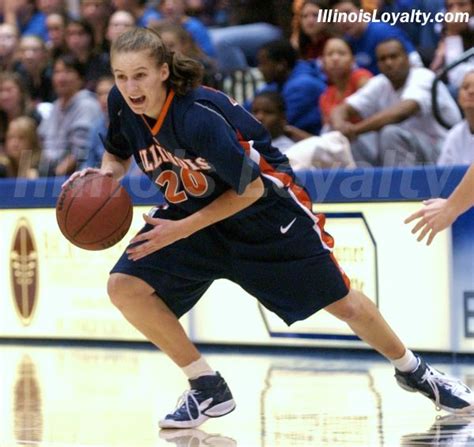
[405,164,474,245]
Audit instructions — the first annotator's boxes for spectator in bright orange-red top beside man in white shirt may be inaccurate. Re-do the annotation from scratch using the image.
[319,37,372,126]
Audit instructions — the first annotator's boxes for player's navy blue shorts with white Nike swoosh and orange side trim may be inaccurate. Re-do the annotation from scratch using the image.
[111,197,350,325]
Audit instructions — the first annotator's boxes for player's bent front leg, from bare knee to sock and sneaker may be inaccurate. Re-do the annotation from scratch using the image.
[107,273,235,428]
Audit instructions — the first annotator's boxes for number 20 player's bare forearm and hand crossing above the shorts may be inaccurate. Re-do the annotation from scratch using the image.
[127,177,264,261]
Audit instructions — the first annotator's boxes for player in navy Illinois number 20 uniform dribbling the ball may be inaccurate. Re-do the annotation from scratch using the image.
[64,28,474,428]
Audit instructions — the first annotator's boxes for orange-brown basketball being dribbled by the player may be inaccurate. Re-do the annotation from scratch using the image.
[56,173,133,250]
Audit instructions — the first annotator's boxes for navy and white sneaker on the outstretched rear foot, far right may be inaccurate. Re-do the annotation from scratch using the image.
[395,357,474,414]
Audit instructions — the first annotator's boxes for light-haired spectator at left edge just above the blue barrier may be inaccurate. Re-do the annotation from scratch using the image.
[0,116,41,178]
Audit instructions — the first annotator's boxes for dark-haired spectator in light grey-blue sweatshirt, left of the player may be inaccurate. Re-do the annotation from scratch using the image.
[38,54,102,176]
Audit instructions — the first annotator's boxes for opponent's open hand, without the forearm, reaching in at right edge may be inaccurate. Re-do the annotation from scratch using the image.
[405,199,456,245]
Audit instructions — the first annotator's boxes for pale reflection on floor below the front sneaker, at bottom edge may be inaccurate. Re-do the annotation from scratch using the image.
[159,428,237,447]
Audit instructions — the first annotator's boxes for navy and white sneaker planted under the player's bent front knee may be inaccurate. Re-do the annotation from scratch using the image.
[159,373,235,428]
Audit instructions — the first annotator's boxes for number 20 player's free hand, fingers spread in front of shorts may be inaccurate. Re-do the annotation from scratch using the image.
[127,214,193,261]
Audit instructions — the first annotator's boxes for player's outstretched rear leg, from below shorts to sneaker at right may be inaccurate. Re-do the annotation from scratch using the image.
[325,290,474,414]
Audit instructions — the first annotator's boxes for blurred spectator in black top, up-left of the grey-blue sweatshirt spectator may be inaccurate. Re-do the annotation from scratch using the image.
[17,36,55,104]
